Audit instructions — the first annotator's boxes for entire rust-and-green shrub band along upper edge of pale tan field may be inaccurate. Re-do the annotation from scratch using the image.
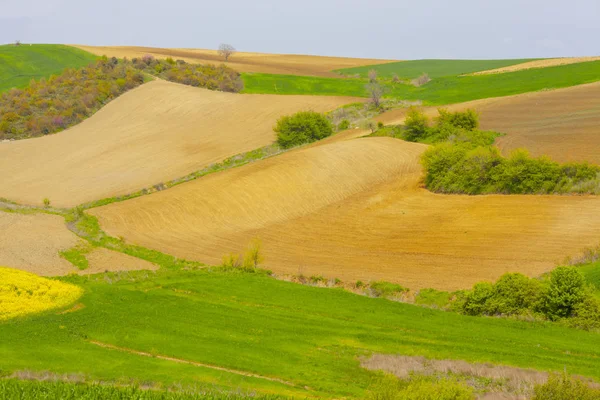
[0,56,244,140]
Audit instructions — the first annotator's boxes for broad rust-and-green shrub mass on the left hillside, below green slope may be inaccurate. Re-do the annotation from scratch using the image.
[0,58,144,139]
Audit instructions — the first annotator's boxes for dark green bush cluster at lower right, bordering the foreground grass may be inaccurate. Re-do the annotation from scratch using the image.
[451,266,600,330]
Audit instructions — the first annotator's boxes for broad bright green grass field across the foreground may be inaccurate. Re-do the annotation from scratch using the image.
[0,271,600,397]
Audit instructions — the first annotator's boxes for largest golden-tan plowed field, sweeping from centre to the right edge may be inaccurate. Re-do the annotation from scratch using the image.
[90,138,600,289]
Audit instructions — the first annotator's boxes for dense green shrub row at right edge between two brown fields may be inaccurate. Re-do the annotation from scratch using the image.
[403,110,600,195]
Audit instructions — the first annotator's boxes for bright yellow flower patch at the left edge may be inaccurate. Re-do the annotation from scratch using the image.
[0,267,83,321]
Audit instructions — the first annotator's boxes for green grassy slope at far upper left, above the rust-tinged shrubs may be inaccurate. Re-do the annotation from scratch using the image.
[0,44,97,92]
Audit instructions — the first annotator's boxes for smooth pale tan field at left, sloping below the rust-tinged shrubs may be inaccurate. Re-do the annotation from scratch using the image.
[0,81,364,207]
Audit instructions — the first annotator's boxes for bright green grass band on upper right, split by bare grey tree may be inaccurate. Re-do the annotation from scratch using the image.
[243,61,600,105]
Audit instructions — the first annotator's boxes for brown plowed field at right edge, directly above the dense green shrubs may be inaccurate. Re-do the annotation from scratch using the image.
[375,82,600,164]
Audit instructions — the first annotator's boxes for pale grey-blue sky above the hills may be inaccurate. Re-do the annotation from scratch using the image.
[0,0,600,59]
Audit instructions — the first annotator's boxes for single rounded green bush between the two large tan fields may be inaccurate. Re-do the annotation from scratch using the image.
[273,111,333,149]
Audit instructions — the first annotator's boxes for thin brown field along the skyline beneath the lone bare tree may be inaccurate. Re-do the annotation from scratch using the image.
[73,45,396,78]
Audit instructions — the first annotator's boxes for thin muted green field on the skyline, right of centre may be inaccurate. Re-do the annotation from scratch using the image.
[336,59,533,79]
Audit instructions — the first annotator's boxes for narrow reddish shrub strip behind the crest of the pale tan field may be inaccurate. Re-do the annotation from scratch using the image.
[131,55,244,93]
